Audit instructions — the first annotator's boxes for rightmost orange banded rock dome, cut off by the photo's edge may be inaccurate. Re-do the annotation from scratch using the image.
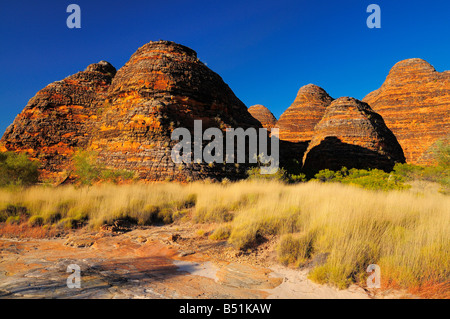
[363,59,450,165]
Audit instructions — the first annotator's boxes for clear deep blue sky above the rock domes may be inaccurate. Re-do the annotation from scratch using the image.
[0,0,450,135]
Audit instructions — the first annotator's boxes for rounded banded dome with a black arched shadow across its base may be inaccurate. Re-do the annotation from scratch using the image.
[303,97,405,172]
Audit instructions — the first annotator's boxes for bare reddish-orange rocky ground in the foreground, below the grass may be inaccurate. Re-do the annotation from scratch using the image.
[0,223,403,299]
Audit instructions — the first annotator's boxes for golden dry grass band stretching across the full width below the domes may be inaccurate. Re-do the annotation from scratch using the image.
[0,180,450,296]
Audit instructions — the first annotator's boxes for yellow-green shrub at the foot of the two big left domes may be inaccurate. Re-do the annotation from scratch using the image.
[72,150,135,185]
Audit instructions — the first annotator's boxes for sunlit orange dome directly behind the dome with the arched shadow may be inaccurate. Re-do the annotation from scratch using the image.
[276,84,333,143]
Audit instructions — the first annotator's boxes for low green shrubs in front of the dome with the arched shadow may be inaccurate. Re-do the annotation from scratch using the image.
[314,167,408,191]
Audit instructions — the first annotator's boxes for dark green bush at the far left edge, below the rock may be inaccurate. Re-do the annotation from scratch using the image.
[0,152,39,187]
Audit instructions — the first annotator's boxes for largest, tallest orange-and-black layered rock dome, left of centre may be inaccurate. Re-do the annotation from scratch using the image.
[91,41,261,180]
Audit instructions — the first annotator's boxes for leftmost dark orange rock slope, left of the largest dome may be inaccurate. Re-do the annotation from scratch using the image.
[1,61,116,177]
